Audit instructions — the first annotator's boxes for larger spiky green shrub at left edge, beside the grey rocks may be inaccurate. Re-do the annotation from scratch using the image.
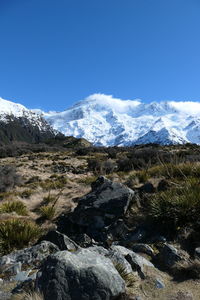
[0,219,42,255]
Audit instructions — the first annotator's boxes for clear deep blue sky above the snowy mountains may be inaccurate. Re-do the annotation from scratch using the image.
[0,0,200,110]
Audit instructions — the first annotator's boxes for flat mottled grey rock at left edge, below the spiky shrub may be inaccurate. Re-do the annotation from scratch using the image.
[0,241,59,281]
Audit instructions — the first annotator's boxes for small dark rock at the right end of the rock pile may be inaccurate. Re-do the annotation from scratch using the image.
[158,243,189,271]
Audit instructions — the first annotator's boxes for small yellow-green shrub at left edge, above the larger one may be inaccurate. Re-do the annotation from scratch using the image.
[0,201,28,216]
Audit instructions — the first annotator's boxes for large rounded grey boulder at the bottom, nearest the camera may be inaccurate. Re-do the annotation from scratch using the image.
[36,249,125,300]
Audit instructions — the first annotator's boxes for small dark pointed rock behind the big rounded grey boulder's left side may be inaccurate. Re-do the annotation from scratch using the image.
[39,230,79,251]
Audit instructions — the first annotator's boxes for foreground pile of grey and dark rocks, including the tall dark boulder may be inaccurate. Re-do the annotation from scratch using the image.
[0,177,198,300]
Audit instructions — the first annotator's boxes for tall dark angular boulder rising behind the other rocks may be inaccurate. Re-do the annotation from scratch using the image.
[58,176,134,241]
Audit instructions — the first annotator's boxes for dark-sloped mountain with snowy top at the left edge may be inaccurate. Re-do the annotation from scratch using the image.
[0,98,56,143]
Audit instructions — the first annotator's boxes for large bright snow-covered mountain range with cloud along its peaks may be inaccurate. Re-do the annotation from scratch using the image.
[40,94,200,146]
